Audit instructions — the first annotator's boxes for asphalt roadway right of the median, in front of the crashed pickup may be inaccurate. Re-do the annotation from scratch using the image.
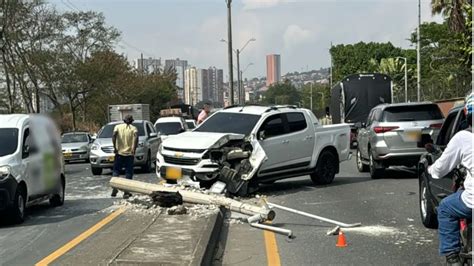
[219,157,444,265]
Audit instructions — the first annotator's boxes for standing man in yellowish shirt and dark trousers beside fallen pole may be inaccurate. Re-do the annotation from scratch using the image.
[111,115,138,199]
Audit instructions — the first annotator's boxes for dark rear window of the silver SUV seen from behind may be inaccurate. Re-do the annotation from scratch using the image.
[383,104,443,122]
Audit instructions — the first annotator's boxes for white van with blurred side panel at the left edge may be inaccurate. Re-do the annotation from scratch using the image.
[0,114,66,223]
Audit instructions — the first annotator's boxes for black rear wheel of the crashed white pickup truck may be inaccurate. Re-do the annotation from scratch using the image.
[311,150,339,185]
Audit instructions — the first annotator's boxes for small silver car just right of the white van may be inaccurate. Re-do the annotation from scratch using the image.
[61,132,92,163]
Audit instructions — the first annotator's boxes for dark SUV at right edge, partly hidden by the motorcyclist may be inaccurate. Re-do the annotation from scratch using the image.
[418,106,468,228]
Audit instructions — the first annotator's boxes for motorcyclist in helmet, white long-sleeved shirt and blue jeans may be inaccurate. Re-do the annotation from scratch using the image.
[428,93,474,265]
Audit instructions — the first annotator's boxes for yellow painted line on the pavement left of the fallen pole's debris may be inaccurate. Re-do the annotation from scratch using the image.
[35,208,125,266]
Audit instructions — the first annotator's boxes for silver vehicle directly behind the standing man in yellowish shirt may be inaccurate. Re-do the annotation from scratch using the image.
[90,120,160,175]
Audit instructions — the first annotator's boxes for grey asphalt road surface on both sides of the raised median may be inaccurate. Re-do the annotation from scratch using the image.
[0,157,443,265]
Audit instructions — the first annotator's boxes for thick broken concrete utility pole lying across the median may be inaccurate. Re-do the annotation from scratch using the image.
[110,177,275,221]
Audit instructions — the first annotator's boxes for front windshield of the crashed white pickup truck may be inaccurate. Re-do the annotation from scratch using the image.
[194,112,260,136]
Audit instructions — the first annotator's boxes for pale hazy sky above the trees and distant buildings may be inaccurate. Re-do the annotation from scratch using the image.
[52,0,441,77]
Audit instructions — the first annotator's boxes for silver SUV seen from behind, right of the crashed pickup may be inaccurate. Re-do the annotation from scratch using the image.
[356,102,444,178]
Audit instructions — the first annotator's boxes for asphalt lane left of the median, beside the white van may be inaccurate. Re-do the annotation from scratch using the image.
[0,163,156,265]
